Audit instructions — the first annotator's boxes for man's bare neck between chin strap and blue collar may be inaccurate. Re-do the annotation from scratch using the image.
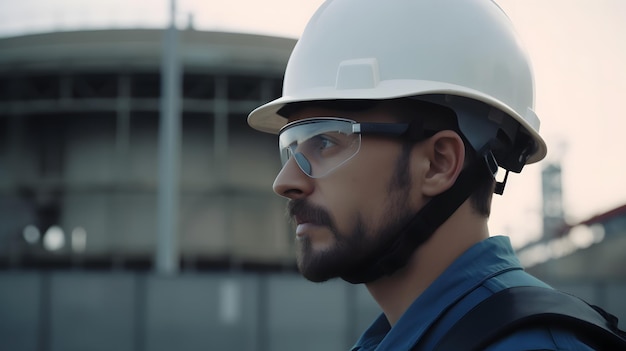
[366,201,489,326]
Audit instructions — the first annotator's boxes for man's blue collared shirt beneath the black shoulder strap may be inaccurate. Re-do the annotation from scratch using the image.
[351,236,592,351]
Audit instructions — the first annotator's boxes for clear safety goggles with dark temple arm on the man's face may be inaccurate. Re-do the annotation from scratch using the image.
[278,117,409,178]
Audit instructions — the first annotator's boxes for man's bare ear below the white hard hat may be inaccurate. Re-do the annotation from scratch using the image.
[422,130,465,196]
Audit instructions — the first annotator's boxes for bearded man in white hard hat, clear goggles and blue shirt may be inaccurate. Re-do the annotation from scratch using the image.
[248,0,608,351]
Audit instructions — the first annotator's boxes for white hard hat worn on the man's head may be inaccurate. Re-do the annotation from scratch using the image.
[248,0,546,163]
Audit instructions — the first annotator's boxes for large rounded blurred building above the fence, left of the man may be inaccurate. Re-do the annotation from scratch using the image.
[0,30,295,268]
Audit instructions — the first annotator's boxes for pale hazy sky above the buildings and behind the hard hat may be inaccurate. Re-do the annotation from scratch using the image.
[0,0,626,245]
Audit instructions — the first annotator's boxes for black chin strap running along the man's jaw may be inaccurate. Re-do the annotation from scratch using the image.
[341,151,504,284]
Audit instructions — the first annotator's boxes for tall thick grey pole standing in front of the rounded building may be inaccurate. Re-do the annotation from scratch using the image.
[155,0,181,274]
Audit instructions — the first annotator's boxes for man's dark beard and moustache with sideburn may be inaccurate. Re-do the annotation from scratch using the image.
[288,142,415,282]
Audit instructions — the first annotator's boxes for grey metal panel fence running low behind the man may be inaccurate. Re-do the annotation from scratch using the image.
[0,271,626,351]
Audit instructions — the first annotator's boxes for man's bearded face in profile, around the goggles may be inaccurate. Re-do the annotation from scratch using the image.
[274,102,422,282]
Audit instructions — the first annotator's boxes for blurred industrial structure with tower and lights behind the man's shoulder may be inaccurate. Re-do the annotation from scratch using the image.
[518,163,626,282]
